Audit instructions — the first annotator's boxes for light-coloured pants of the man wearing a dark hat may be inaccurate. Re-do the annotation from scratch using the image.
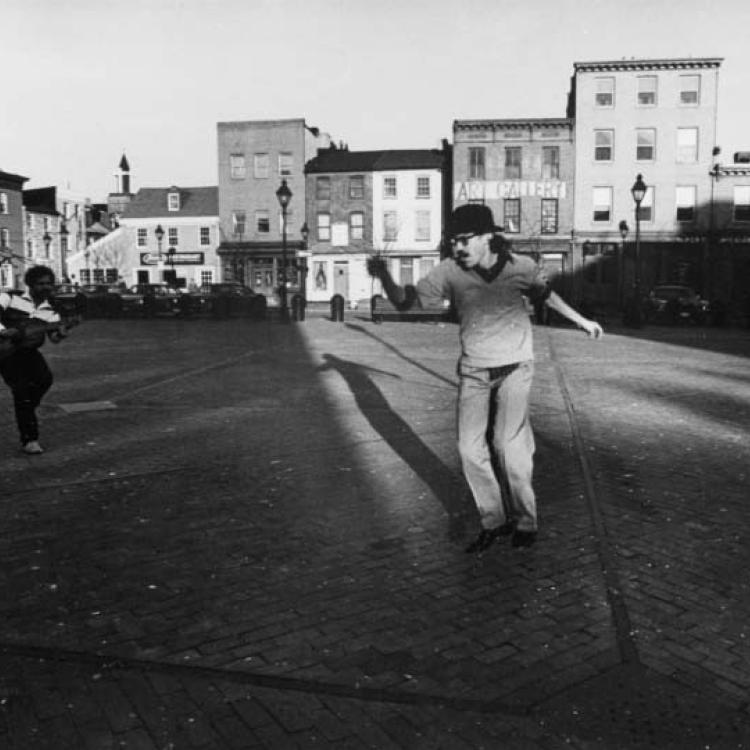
[458,361,537,531]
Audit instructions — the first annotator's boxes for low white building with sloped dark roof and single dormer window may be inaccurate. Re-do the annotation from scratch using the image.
[70,186,221,287]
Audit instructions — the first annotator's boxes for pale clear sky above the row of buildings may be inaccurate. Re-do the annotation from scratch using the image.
[5,0,750,202]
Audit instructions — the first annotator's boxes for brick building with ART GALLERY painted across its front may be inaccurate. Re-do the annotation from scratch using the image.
[453,118,575,291]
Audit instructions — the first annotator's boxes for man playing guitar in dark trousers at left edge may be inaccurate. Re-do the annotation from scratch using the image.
[0,266,67,455]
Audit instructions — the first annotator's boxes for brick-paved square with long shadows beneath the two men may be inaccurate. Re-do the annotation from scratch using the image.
[0,314,750,750]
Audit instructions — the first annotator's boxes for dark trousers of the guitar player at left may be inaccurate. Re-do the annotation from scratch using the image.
[0,349,52,445]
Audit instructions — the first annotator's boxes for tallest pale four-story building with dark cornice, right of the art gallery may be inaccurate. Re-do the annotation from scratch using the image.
[568,58,722,302]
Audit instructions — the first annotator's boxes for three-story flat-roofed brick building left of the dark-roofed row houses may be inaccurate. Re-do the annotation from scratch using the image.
[217,118,330,306]
